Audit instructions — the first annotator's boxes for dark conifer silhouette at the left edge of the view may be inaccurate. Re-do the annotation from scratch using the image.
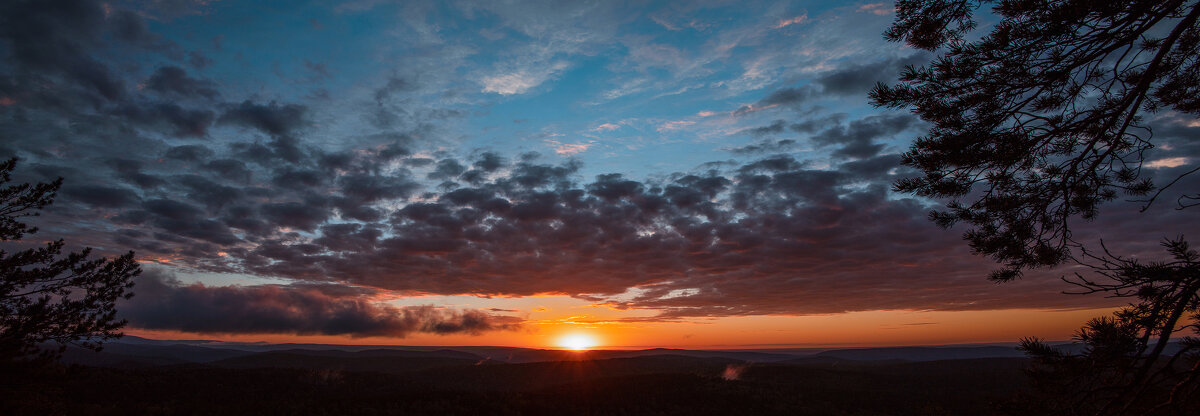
[0,158,142,361]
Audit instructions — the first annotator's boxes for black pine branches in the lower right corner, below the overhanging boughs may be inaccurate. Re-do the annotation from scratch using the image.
[1020,239,1200,415]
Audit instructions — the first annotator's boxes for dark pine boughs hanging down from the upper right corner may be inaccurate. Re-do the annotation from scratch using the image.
[871,0,1200,281]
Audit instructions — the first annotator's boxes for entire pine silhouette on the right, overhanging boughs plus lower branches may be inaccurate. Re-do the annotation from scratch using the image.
[871,0,1200,414]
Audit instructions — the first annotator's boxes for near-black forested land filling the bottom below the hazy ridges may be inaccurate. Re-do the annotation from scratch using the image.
[14,350,1027,416]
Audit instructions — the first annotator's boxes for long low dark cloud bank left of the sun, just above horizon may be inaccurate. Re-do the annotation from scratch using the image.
[118,270,521,337]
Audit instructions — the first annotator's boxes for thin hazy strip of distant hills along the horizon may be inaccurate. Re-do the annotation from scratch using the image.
[62,337,1180,370]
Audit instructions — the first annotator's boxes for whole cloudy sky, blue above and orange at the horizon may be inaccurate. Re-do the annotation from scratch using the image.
[0,0,1200,348]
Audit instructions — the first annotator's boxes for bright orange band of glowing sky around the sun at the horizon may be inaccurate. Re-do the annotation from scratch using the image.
[125,308,1115,350]
